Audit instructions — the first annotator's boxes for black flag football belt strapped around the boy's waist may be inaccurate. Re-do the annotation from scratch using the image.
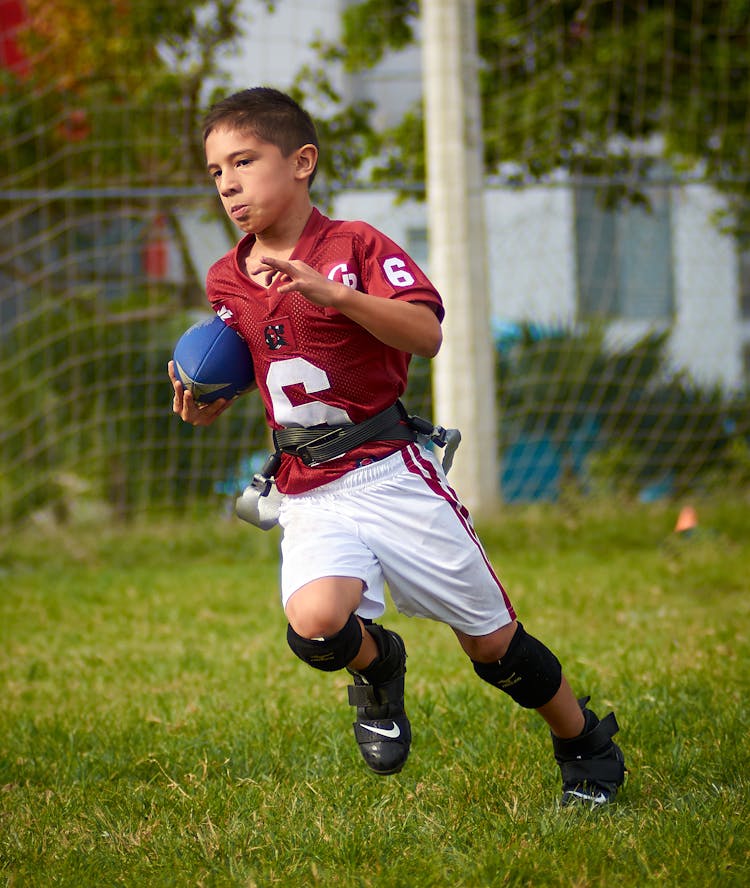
[273,401,460,466]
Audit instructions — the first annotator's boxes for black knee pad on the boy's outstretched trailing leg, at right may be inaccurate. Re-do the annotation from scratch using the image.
[472,623,562,709]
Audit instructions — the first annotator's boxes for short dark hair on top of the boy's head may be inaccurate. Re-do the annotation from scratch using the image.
[203,86,318,184]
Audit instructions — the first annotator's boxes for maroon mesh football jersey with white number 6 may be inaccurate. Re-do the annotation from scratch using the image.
[207,210,443,493]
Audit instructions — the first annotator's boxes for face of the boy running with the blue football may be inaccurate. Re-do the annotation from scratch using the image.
[205,128,317,234]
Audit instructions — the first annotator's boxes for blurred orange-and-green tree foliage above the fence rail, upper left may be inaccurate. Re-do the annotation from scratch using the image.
[1,0,262,182]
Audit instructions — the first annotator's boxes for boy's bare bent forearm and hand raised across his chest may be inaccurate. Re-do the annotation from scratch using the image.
[253,256,443,358]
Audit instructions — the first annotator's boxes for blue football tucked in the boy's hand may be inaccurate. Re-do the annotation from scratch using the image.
[173,315,255,404]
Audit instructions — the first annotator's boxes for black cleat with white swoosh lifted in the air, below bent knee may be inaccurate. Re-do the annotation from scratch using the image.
[348,623,411,774]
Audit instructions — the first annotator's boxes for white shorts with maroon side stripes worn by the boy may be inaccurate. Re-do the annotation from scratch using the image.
[279,444,515,635]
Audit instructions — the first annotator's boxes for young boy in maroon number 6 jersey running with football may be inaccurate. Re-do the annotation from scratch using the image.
[169,87,625,805]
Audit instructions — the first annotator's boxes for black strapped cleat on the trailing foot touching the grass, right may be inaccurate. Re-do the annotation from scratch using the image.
[552,697,627,808]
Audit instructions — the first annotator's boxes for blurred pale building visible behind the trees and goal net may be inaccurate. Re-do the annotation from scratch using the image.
[0,0,750,390]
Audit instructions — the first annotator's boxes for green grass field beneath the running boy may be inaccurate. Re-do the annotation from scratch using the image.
[0,494,750,888]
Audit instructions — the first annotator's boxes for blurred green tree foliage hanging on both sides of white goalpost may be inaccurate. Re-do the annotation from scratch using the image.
[300,0,750,225]
